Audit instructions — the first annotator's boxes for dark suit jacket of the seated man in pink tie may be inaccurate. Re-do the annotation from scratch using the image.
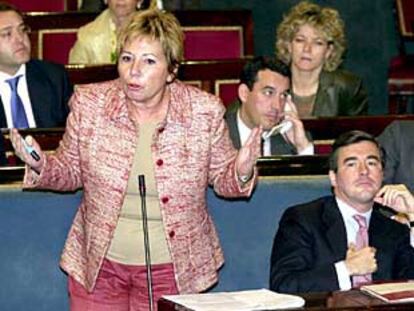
[270,196,414,293]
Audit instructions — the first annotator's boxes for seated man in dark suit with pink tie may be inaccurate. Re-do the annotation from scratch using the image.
[270,131,414,293]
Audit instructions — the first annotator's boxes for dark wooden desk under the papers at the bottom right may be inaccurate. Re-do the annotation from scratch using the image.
[158,290,414,311]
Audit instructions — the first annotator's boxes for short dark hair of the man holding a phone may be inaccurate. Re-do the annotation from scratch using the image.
[240,56,290,90]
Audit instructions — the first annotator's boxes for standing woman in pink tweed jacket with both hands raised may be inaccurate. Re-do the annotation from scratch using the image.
[10,10,262,311]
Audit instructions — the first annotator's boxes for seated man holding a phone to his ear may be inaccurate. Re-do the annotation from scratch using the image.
[225,57,314,156]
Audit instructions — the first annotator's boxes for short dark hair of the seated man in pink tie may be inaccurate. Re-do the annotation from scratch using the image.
[329,130,385,173]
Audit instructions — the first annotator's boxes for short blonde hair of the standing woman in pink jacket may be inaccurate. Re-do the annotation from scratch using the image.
[118,9,184,73]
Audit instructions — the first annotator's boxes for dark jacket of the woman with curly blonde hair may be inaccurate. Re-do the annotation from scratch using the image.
[312,70,368,117]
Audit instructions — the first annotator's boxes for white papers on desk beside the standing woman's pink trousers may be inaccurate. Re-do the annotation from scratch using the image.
[163,289,305,311]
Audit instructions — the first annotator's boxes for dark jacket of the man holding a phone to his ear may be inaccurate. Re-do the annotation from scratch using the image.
[225,101,297,155]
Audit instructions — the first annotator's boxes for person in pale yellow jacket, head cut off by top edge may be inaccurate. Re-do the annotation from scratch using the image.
[69,0,156,64]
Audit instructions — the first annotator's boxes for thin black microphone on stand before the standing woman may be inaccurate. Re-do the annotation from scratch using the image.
[138,175,154,311]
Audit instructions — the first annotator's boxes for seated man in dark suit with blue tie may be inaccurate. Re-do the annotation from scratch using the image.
[0,2,73,128]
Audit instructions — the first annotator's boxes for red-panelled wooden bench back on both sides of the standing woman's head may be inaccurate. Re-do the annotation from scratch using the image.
[25,10,254,64]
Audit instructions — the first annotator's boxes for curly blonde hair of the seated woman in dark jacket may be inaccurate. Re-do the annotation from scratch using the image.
[276,1,346,71]
